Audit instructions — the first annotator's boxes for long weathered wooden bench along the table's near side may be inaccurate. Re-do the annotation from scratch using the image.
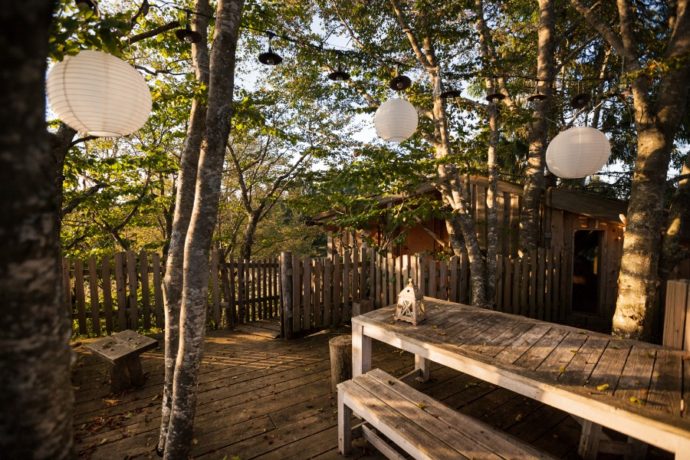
[338,369,550,459]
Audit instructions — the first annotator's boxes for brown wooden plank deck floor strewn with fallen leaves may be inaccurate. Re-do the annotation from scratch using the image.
[73,323,660,460]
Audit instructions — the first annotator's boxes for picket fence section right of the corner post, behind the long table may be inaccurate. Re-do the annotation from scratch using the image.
[280,249,567,338]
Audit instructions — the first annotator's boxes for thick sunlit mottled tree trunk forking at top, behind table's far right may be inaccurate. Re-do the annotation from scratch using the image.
[571,0,690,339]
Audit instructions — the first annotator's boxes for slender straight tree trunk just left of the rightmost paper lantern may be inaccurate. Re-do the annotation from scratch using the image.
[520,0,556,254]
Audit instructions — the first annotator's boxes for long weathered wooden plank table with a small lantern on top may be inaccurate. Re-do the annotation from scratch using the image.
[352,297,690,459]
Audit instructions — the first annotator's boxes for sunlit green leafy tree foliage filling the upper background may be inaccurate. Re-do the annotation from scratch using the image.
[50,0,690,255]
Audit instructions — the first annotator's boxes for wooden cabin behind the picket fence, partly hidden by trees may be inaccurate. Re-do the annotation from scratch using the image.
[314,176,627,330]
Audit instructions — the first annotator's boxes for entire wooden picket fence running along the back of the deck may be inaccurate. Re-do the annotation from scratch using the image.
[63,249,568,338]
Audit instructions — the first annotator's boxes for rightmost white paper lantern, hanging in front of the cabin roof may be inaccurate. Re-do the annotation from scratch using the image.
[546,126,611,179]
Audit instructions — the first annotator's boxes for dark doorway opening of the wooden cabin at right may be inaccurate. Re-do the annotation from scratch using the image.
[573,230,604,313]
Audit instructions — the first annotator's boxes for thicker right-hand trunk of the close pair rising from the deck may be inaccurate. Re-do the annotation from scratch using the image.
[164,0,243,460]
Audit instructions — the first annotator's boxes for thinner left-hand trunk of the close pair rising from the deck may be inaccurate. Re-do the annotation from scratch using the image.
[157,0,212,454]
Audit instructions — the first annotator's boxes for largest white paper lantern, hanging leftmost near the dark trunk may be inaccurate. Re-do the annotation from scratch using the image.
[47,51,151,137]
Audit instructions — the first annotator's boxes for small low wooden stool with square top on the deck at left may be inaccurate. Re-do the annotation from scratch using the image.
[85,330,158,393]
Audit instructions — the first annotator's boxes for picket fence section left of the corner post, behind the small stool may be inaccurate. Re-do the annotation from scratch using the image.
[63,251,280,336]
